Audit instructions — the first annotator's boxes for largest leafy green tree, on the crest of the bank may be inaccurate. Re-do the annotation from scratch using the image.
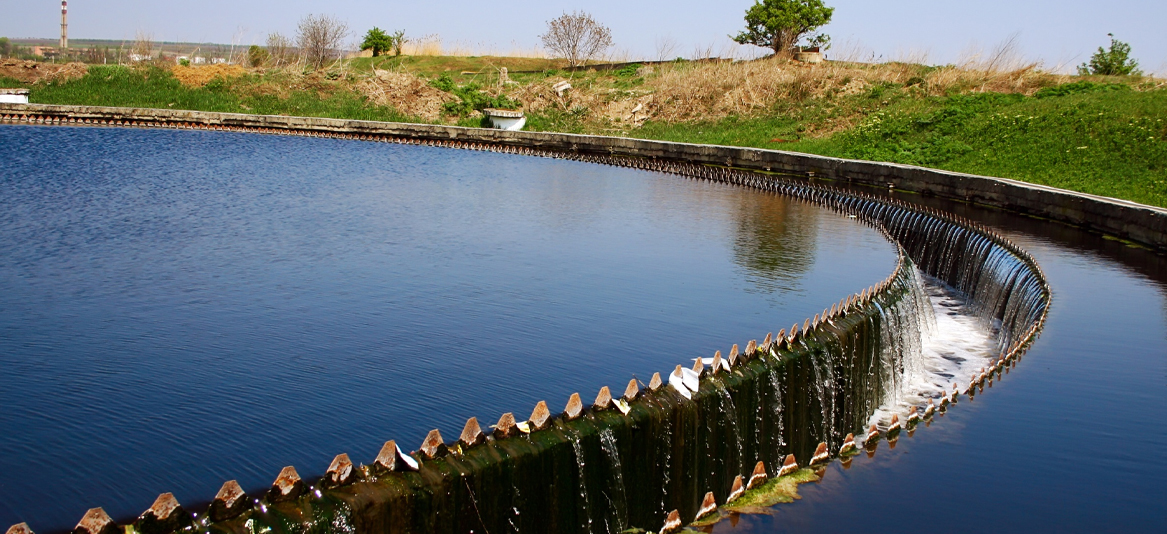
[733,0,834,55]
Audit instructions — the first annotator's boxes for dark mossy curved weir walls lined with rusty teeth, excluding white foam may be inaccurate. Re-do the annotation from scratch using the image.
[0,105,1050,534]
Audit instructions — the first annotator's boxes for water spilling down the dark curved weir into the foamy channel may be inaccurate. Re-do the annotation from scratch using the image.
[45,148,1050,534]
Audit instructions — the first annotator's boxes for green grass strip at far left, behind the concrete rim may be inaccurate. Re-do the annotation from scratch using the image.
[20,65,415,121]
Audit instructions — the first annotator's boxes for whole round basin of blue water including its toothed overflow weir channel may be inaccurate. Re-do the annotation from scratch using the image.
[20,112,1167,534]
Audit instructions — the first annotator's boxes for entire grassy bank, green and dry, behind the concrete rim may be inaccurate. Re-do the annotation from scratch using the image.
[0,56,1167,206]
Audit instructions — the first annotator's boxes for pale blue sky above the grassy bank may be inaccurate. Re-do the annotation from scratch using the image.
[0,0,1167,73]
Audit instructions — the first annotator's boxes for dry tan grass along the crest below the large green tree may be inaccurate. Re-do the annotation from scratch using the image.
[511,54,1069,130]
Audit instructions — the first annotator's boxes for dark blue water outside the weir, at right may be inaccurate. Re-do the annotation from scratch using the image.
[713,195,1167,533]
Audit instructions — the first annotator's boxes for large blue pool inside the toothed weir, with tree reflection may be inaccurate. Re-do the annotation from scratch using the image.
[0,126,895,533]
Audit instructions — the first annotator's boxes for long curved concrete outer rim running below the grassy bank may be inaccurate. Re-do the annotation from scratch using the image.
[0,104,1167,253]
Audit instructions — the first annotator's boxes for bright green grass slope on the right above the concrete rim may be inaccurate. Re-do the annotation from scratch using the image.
[616,87,1167,208]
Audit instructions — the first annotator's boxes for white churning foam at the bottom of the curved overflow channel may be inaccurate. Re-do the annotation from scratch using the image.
[867,277,997,429]
